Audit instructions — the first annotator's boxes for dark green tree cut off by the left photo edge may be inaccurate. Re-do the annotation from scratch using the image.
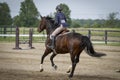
[0,3,12,25]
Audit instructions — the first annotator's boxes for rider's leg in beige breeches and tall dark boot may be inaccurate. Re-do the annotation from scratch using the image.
[48,25,64,49]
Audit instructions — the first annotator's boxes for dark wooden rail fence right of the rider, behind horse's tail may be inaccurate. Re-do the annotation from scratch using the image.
[72,29,120,44]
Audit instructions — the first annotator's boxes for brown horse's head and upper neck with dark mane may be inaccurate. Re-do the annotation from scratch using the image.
[37,16,54,32]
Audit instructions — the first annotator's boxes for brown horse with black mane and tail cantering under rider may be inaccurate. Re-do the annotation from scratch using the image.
[37,15,105,78]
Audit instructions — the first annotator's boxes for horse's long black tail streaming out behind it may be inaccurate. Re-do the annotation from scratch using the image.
[84,36,106,57]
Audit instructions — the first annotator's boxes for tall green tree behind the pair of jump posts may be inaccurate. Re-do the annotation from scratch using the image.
[19,0,39,27]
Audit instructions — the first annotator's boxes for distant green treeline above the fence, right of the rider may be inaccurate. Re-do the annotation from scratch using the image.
[71,12,120,28]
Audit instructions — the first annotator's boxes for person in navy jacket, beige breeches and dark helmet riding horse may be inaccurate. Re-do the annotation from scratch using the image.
[48,5,68,49]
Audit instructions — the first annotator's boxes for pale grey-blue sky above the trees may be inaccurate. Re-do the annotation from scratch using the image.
[0,0,120,19]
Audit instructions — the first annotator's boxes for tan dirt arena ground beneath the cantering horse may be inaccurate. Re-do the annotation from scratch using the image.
[0,43,120,80]
